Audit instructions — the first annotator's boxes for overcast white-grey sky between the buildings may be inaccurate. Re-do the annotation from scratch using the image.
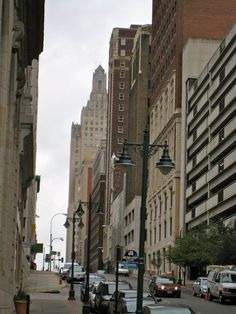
[36,0,152,269]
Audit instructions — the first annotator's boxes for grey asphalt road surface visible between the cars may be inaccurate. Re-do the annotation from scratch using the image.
[71,274,236,314]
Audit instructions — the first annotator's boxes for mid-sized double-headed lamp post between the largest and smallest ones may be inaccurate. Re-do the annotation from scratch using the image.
[79,194,104,314]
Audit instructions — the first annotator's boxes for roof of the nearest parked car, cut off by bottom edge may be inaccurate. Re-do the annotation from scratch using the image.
[143,304,196,314]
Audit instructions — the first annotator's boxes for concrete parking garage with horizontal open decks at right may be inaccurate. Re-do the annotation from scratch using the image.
[185,26,236,230]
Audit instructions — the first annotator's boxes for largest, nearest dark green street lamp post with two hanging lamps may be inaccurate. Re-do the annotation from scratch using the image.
[116,128,174,314]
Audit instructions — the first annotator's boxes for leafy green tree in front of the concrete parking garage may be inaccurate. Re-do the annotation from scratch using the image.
[167,223,236,268]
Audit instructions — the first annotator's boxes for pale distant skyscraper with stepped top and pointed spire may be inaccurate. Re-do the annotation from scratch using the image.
[66,65,107,263]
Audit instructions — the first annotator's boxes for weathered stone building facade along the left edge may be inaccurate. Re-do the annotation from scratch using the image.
[0,0,44,314]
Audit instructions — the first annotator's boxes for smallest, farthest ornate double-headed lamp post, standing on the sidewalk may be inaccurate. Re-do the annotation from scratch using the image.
[64,206,84,300]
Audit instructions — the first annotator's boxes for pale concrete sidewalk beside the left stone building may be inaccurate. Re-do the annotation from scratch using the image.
[25,270,82,314]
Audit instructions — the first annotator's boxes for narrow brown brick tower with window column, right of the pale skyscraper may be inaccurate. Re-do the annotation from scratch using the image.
[105,25,137,224]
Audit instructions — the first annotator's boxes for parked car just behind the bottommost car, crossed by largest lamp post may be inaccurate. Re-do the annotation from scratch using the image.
[117,297,156,314]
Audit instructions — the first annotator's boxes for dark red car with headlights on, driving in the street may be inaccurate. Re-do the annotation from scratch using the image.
[149,276,181,298]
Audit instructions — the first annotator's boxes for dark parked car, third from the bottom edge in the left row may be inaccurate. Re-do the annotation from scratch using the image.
[108,289,155,314]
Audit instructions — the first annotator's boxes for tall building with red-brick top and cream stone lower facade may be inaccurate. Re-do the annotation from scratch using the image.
[146,0,236,273]
